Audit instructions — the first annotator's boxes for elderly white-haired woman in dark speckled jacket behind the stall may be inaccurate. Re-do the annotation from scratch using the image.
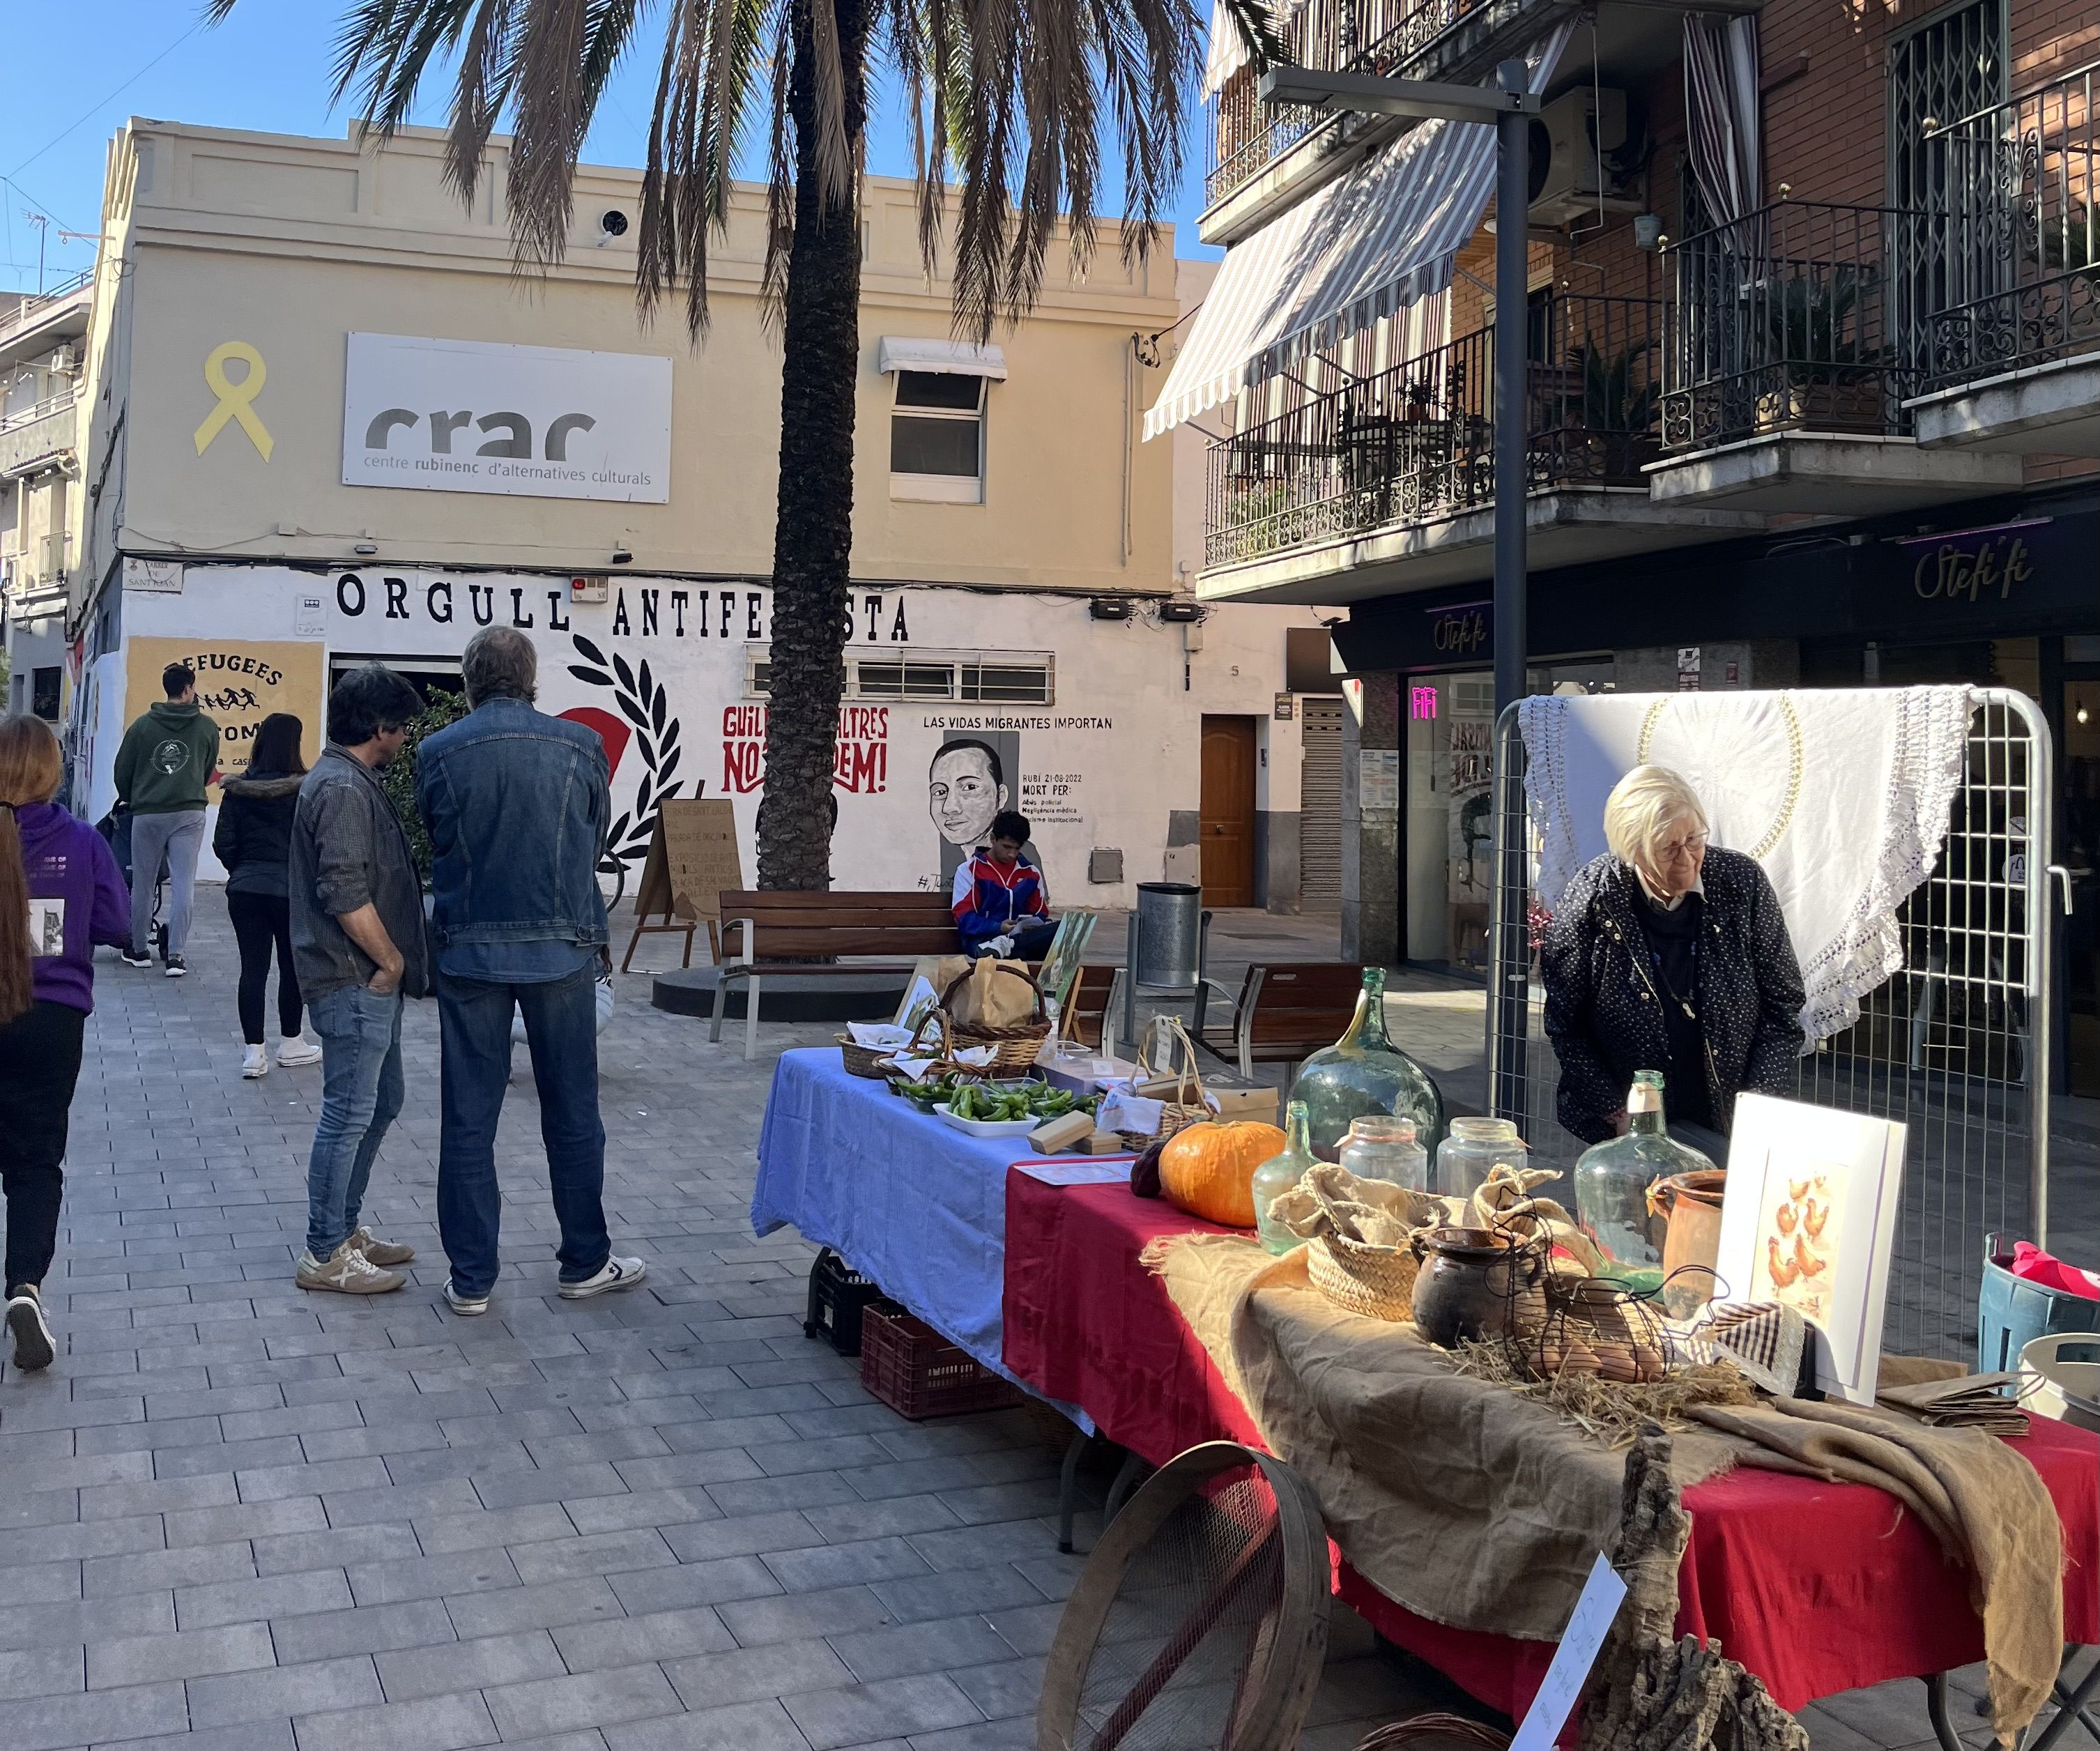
[1542,766,1802,1161]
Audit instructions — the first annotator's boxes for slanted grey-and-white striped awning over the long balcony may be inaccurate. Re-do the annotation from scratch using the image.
[1144,23,1569,439]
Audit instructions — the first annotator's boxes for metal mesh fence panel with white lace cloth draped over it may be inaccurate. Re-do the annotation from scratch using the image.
[1487,689,2054,1361]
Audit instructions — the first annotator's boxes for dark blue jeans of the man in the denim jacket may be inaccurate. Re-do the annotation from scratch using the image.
[437,961,611,1295]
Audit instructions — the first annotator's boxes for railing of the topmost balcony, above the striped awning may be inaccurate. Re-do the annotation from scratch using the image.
[1203,0,1573,206]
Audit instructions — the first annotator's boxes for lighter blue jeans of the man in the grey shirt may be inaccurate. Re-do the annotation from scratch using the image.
[307,985,401,1260]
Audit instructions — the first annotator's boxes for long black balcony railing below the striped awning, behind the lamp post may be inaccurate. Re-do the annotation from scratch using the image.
[1203,296,1659,567]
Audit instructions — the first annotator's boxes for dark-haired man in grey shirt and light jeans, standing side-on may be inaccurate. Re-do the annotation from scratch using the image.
[288,664,431,1295]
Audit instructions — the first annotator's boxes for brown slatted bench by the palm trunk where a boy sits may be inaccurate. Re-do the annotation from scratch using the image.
[707,888,962,1058]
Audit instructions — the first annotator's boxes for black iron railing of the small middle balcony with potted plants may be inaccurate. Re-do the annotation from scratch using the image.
[1663,201,1924,450]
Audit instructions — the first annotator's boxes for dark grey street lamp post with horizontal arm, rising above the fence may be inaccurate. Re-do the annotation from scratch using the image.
[1260,61,1540,718]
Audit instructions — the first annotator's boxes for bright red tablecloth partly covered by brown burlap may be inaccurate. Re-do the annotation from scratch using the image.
[1006,1172,2100,1715]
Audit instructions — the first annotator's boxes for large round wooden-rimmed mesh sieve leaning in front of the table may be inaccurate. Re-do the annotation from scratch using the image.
[1035,1440,1329,1751]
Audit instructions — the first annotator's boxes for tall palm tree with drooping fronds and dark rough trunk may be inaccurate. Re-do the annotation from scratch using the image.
[206,0,1243,888]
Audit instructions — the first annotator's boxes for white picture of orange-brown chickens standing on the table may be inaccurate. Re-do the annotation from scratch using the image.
[1716,1094,1905,1405]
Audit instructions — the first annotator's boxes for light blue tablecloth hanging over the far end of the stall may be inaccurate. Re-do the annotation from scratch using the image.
[752,1046,1037,1379]
